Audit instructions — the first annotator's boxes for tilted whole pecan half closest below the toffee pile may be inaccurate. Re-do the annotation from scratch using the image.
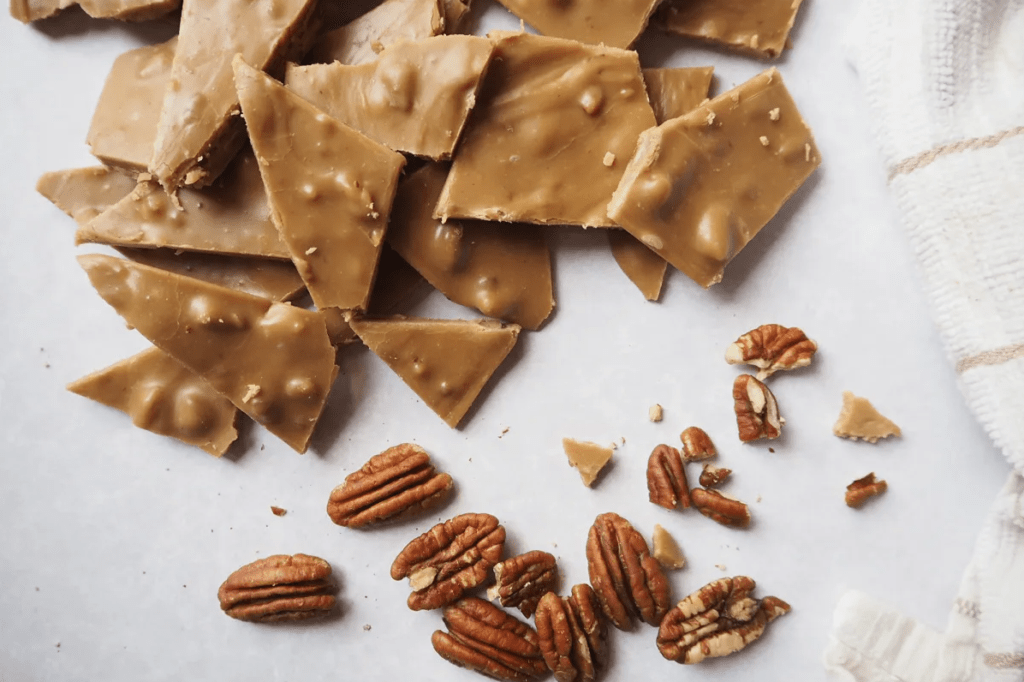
[327,442,452,528]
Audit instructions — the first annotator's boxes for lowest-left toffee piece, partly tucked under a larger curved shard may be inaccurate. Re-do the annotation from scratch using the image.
[68,348,239,457]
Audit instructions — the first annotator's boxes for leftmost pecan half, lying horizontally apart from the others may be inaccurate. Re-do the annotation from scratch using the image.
[217,554,335,623]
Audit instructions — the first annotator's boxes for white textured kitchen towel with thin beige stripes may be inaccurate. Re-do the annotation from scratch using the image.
[825,0,1024,682]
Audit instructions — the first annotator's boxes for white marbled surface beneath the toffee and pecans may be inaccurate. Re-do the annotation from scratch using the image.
[0,0,1009,682]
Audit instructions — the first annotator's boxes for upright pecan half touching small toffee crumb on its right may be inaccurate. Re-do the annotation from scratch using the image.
[587,512,672,630]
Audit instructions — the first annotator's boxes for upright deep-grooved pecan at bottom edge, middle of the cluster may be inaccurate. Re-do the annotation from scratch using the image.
[534,584,604,682]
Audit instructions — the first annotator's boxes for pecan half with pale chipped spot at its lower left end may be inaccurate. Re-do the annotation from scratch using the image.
[391,507,505,611]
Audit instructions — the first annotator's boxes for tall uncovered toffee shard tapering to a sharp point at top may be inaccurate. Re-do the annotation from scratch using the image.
[234,57,406,310]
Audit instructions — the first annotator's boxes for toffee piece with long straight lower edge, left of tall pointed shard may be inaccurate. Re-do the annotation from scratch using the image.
[75,152,290,258]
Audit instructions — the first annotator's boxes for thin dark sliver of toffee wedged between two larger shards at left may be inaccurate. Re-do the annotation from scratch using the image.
[118,247,306,301]
